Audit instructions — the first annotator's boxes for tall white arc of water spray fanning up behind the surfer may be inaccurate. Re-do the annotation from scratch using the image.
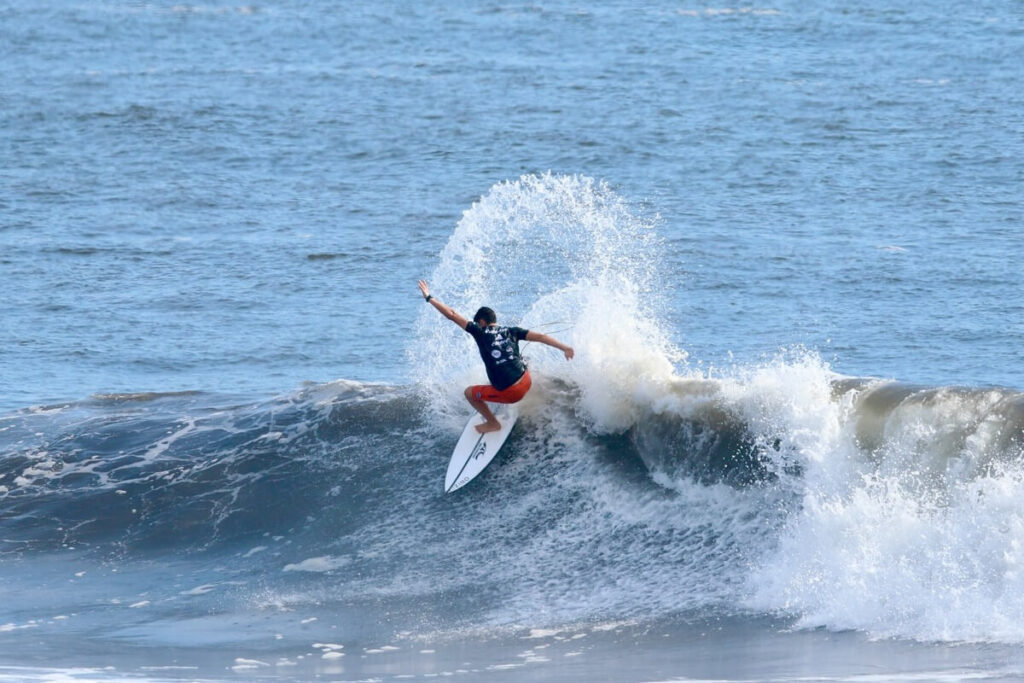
[410,174,684,431]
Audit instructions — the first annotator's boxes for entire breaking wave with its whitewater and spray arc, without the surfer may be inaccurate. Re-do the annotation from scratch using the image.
[0,176,1024,643]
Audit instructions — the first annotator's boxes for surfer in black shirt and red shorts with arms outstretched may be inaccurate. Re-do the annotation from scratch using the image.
[420,280,575,434]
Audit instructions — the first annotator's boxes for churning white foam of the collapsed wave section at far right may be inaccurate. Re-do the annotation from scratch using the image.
[731,364,1024,642]
